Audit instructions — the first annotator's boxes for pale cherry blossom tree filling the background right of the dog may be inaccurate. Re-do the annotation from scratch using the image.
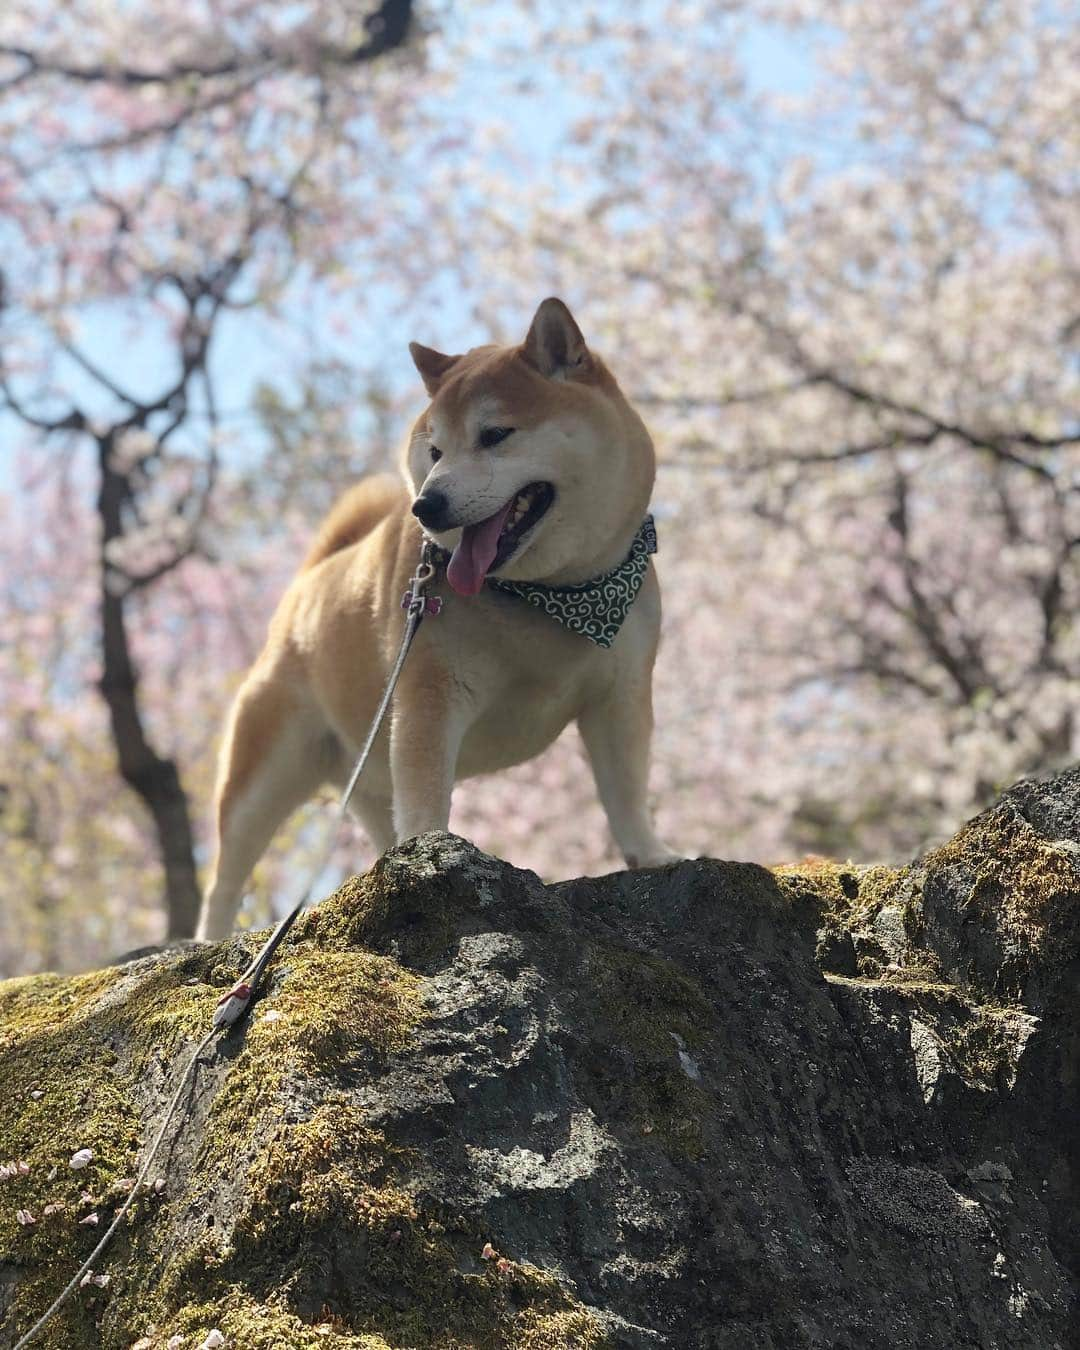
[437,3,1080,857]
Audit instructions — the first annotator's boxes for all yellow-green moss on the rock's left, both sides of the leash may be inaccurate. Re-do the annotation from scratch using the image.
[0,886,603,1350]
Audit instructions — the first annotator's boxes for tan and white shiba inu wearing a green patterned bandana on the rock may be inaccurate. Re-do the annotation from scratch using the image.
[198,300,676,938]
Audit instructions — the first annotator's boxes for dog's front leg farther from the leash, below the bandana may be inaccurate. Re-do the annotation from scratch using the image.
[578,672,679,867]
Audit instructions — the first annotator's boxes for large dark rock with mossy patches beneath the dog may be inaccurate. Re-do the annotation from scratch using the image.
[0,774,1080,1350]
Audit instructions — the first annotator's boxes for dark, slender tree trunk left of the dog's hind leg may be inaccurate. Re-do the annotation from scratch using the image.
[97,441,200,938]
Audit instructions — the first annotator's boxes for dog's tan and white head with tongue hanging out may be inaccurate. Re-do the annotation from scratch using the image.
[404,300,655,595]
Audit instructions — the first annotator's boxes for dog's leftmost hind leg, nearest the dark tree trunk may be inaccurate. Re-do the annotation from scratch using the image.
[196,672,329,941]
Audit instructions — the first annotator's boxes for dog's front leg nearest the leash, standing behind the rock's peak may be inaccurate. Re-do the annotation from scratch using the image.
[390,647,464,844]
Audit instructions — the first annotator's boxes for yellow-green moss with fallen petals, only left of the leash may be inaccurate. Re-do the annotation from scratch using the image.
[0,960,216,1350]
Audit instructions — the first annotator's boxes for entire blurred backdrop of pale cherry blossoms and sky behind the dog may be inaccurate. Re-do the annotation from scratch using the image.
[0,0,1080,964]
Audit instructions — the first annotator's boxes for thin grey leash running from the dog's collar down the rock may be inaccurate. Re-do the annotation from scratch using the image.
[14,539,443,1350]
